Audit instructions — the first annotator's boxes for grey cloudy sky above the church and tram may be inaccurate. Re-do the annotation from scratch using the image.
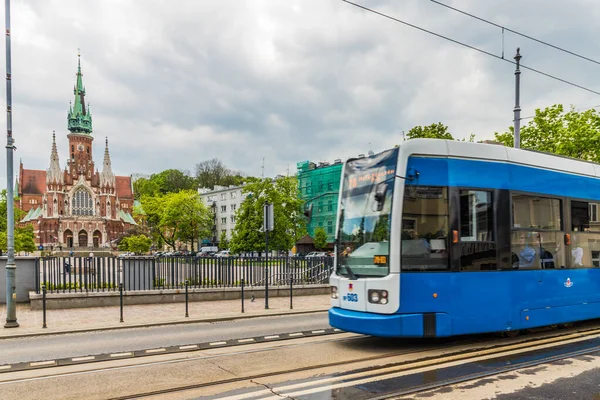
[0,0,600,186]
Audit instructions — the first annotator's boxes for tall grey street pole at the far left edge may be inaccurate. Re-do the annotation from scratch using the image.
[4,0,19,328]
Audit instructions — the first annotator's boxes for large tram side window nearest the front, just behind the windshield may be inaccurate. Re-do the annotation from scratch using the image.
[402,185,448,271]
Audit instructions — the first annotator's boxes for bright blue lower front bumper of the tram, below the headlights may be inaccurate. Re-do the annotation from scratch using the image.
[329,307,451,337]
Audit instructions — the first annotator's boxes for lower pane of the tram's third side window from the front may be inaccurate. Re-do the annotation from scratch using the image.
[511,230,565,269]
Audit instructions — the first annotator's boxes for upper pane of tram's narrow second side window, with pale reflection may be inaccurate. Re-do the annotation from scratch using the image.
[460,190,494,242]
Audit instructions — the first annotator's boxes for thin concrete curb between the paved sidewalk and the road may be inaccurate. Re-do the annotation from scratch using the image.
[0,307,330,341]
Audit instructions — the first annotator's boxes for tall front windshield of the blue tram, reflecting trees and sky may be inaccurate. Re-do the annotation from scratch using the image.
[336,148,398,279]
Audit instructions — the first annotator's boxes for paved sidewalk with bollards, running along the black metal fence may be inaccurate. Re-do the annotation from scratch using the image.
[0,295,329,339]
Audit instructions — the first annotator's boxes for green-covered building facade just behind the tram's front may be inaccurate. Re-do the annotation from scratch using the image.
[296,159,343,243]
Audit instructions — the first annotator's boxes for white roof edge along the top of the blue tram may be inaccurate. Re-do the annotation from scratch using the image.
[400,139,600,178]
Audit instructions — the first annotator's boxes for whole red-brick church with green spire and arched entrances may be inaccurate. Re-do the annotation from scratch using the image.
[15,54,135,249]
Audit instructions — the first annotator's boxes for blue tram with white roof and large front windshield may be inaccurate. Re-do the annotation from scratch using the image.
[329,139,600,337]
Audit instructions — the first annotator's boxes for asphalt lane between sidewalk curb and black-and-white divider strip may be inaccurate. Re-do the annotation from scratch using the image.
[0,312,330,365]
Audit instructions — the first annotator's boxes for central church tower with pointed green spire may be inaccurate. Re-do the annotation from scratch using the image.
[67,54,94,181]
